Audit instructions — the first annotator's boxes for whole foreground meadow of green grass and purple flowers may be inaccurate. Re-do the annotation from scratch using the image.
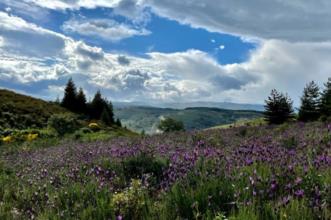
[0,122,331,220]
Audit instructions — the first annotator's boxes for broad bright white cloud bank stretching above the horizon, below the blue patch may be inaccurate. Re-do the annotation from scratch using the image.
[0,13,331,103]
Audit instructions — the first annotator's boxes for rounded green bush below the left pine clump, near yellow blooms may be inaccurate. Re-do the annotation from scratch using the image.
[48,114,79,136]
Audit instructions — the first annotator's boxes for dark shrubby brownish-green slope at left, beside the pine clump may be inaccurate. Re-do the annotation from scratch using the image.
[0,89,66,129]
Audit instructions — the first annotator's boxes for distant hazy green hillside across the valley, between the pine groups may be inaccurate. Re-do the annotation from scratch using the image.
[114,106,262,134]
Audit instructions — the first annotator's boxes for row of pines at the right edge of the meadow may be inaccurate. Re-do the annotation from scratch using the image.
[264,78,331,124]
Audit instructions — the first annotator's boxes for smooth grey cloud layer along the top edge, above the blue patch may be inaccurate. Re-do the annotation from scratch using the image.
[23,0,331,41]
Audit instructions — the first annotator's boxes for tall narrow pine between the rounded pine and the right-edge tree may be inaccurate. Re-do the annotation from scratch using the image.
[299,81,320,121]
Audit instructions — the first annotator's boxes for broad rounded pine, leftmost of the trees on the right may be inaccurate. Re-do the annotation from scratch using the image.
[264,89,293,124]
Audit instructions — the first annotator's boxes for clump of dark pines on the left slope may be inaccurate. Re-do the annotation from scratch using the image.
[58,78,121,126]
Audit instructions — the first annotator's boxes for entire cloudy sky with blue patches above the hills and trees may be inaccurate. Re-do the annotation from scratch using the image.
[0,0,331,106]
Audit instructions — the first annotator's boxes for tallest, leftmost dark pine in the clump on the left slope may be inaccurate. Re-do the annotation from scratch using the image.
[61,78,77,112]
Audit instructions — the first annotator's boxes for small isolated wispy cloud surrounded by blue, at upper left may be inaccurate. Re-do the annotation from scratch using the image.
[62,19,151,41]
